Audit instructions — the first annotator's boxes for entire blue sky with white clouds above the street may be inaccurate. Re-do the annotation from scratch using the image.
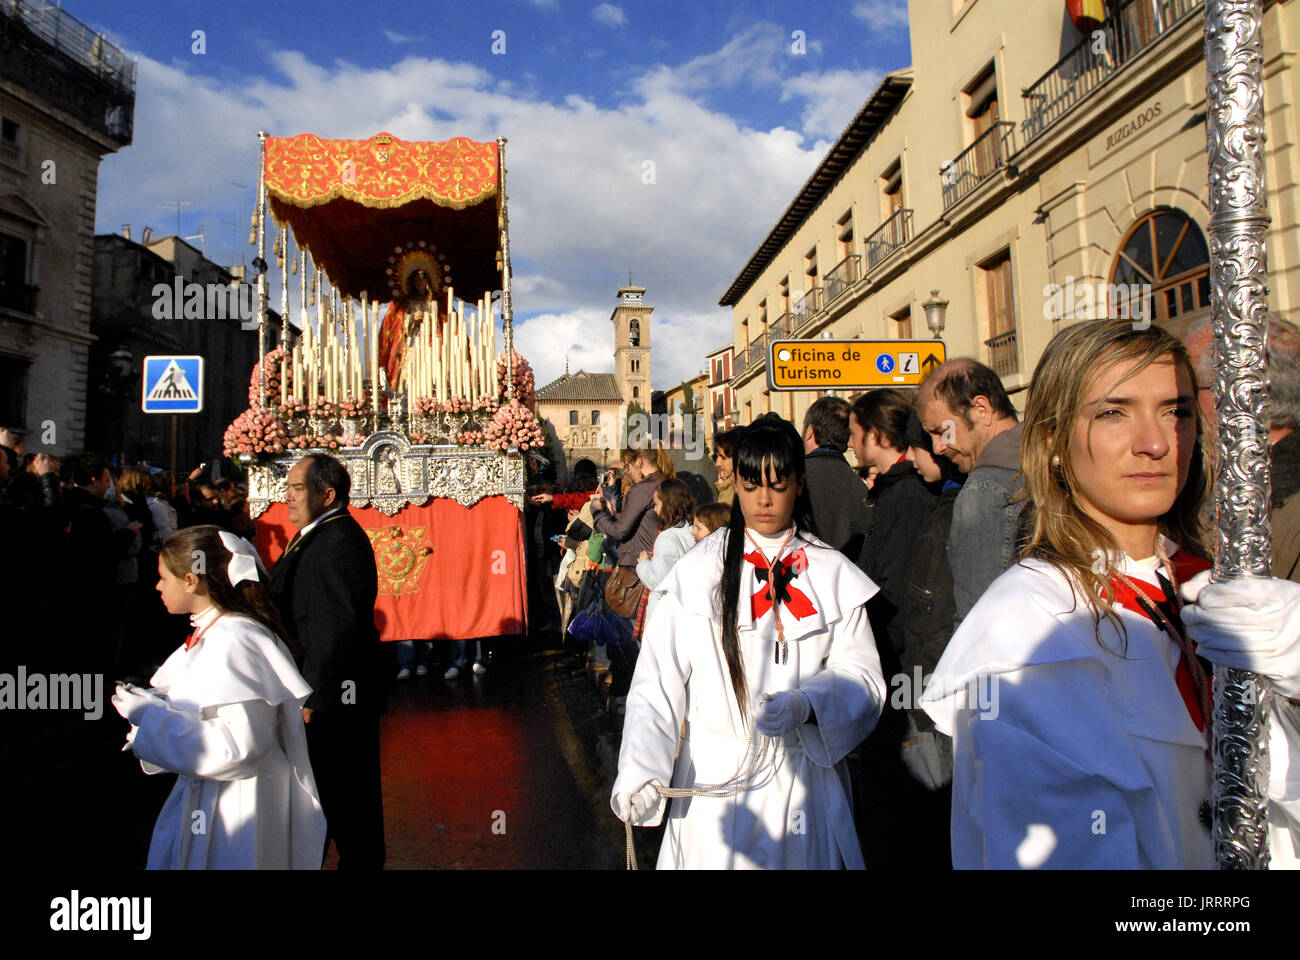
[76,0,910,389]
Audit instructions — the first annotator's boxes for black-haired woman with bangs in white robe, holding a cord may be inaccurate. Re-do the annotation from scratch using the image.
[611,414,885,869]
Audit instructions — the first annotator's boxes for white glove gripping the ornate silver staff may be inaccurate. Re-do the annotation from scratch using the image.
[1183,570,1300,699]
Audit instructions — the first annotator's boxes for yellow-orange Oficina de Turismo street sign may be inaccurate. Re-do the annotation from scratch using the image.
[767,340,948,390]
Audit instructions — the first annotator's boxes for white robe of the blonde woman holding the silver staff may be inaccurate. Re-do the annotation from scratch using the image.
[922,540,1300,869]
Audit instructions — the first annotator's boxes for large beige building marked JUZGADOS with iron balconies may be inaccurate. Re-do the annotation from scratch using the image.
[720,0,1300,424]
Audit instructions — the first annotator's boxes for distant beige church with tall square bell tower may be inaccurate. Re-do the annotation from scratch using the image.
[537,284,654,470]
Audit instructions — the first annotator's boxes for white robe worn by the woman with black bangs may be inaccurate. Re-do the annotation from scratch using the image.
[614,528,885,869]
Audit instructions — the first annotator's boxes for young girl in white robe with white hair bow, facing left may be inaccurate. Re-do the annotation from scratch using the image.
[113,526,325,870]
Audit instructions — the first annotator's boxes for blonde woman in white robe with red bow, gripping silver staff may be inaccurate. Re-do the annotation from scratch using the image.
[922,321,1300,869]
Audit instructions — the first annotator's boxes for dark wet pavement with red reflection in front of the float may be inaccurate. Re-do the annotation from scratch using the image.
[371,642,623,869]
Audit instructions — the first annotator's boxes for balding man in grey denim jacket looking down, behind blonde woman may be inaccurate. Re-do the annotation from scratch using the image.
[917,356,1024,626]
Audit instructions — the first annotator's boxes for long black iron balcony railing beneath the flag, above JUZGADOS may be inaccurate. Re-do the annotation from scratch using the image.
[1021,0,1203,146]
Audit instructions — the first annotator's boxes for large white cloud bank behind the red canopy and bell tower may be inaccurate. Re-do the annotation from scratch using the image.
[98,25,870,389]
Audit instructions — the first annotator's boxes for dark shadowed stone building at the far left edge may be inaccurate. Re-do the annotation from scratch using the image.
[0,0,135,454]
